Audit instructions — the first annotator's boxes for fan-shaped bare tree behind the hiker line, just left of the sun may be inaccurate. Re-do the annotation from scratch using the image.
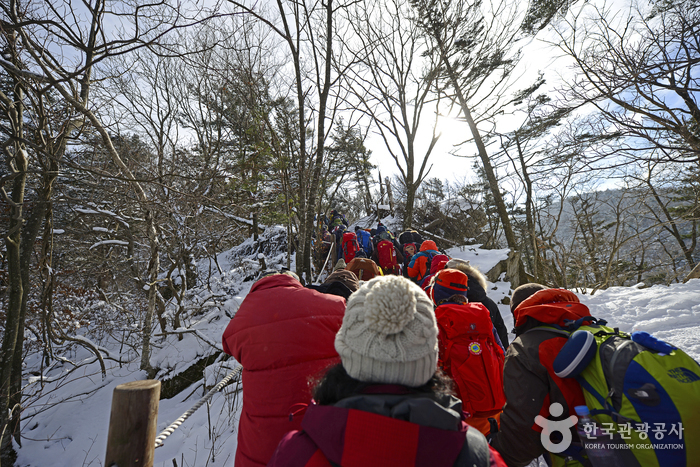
[348,0,440,228]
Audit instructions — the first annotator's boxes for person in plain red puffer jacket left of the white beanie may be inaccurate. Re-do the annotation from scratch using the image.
[223,272,345,467]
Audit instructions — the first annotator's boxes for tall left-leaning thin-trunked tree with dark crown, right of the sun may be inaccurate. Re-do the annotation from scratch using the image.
[412,0,532,252]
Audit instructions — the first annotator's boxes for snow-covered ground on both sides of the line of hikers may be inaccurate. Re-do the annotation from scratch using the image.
[16,236,700,467]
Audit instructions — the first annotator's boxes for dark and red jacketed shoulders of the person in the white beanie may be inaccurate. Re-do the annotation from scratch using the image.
[268,385,505,467]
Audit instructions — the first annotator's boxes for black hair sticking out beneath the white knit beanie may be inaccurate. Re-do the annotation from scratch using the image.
[312,363,455,405]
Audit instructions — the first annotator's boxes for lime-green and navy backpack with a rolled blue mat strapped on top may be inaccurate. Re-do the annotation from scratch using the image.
[544,317,700,467]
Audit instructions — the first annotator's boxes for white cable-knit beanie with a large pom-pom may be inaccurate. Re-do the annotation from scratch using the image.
[335,275,438,387]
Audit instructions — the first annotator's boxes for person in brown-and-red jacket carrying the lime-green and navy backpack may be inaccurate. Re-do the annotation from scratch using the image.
[491,284,590,467]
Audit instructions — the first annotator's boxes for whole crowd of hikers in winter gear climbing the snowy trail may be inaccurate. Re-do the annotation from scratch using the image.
[223,213,700,467]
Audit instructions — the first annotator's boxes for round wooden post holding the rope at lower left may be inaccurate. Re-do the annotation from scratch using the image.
[105,379,160,467]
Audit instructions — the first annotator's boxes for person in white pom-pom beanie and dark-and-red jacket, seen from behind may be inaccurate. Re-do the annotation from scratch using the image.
[268,275,505,467]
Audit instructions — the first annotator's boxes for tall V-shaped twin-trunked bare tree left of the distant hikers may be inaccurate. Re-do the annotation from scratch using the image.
[228,0,356,280]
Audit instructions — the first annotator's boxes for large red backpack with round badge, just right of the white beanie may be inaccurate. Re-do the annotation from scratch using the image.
[435,303,506,416]
